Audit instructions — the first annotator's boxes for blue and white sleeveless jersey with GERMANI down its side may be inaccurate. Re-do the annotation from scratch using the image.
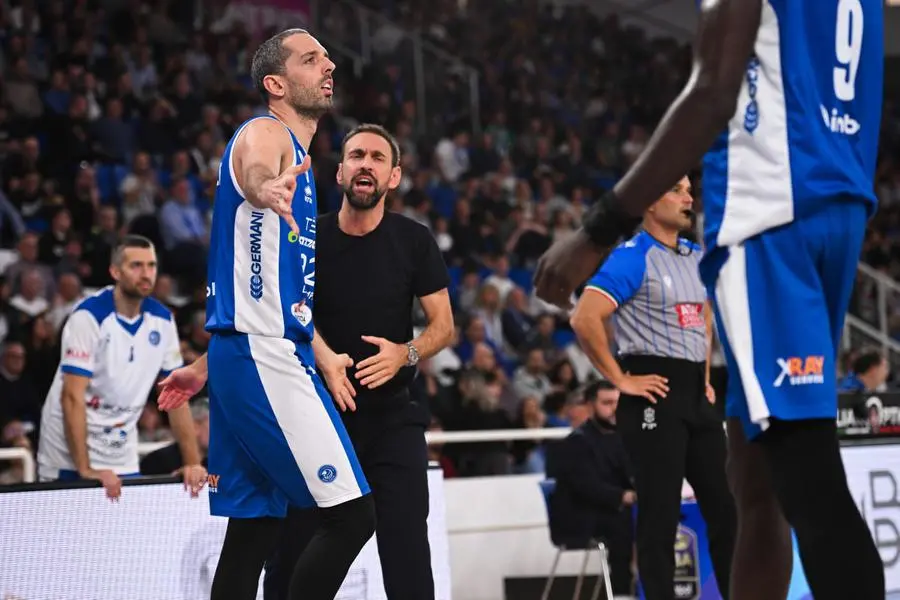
[206,116,317,352]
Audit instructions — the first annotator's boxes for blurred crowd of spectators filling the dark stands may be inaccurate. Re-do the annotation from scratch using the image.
[0,0,900,483]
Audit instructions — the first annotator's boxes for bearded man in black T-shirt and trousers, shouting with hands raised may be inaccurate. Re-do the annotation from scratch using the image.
[264,125,454,600]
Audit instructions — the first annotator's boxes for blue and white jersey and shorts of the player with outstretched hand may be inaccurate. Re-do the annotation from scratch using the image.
[206,116,369,517]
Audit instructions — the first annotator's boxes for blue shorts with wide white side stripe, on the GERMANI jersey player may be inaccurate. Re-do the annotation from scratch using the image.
[207,334,369,518]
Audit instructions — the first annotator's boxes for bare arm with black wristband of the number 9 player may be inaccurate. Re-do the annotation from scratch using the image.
[535,0,765,308]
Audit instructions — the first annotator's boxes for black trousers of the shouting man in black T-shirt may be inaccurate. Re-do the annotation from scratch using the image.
[263,399,434,600]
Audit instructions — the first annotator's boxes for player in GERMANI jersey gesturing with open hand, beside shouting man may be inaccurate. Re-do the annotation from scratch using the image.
[159,29,375,600]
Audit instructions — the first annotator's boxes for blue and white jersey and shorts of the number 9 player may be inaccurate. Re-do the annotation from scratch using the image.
[701,0,884,438]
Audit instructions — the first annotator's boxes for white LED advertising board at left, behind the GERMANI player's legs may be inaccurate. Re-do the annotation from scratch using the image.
[0,469,450,600]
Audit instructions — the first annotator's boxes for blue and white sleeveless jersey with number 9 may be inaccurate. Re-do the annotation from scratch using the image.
[703,0,884,248]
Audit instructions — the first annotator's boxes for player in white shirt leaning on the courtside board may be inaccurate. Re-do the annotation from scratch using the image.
[37,235,207,499]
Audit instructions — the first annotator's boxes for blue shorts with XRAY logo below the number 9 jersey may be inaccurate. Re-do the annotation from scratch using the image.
[700,201,868,439]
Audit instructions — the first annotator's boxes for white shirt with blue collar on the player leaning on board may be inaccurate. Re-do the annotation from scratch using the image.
[38,287,182,481]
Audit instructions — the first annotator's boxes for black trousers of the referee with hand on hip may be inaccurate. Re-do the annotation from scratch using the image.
[616,356,737,600]
